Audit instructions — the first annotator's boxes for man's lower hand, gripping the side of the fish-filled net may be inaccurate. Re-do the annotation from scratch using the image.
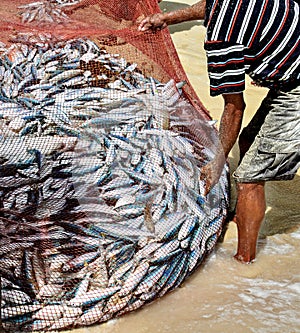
[200,159,225,196]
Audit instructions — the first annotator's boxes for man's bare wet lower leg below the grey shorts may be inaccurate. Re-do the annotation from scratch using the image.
[235,182,266,263]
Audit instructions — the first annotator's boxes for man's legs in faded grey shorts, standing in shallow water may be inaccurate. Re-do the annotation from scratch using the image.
[233,87,300,262]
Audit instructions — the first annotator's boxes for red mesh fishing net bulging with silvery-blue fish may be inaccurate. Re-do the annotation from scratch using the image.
[0,0,228,332]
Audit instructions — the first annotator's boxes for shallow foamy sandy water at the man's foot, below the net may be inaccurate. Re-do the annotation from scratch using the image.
[67,217,300,333]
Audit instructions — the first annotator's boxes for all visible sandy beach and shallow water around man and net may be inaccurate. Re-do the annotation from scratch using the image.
[68,0,300,333]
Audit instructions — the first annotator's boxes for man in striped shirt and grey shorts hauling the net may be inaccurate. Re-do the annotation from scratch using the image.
[138,0,300,263]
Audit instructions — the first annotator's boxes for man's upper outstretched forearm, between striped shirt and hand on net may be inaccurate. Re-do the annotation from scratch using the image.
[159,0,206,25]
